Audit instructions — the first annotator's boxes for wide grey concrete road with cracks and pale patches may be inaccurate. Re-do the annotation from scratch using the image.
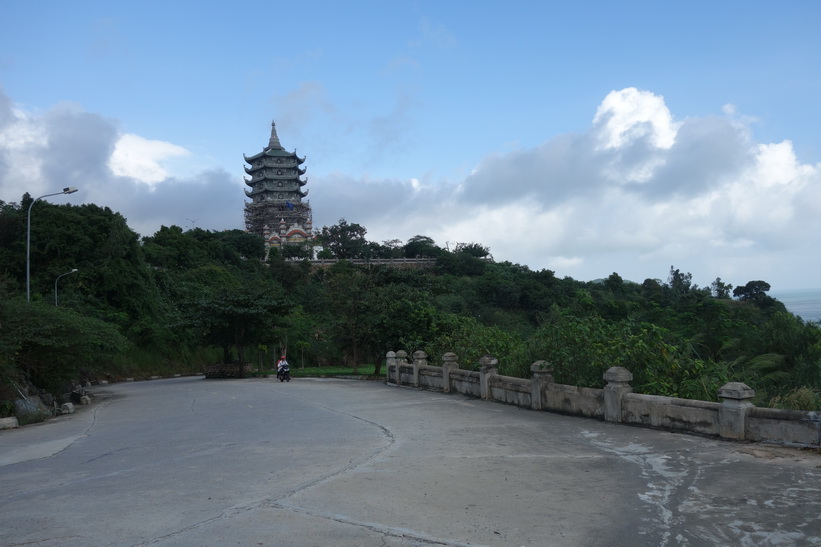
[0,377,821,547]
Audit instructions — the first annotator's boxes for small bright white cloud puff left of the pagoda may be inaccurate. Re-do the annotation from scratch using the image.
[108,133,190,185]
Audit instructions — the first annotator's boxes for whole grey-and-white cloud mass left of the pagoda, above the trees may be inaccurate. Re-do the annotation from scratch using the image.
[0,92,244,235]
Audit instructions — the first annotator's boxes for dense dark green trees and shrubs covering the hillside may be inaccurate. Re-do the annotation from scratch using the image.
[0,195,821,416]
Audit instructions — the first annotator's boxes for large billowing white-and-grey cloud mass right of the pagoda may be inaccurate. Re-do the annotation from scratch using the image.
[314,88,821,287]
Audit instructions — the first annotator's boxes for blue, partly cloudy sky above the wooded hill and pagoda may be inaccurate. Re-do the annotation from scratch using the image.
[0,0,821,293]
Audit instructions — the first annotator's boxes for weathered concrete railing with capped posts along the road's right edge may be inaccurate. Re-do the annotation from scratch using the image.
[385,351,821,448]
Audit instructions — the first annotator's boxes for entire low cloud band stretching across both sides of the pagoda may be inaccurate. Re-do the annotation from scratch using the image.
[0,88,821,289]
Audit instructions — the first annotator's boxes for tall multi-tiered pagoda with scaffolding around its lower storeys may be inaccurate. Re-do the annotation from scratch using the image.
[242,122,312,255]
